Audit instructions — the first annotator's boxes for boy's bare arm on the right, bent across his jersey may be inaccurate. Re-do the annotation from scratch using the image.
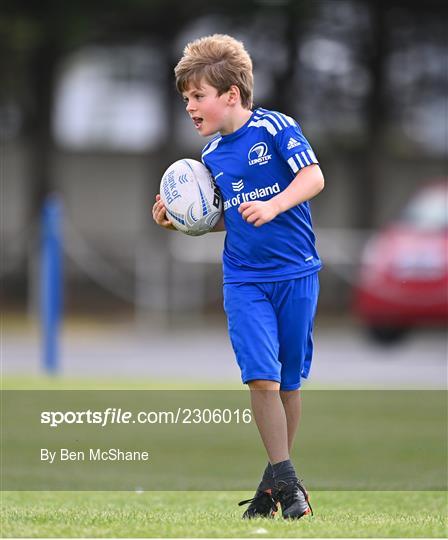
[238,165,324,227]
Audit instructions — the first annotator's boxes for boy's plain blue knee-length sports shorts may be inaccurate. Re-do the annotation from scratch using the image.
[224,272,319,390]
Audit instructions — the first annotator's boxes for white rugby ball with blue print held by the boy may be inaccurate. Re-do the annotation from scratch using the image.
[160,159,222,236]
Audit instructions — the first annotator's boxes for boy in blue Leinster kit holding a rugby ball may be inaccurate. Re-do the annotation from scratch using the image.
[153,34,324,519]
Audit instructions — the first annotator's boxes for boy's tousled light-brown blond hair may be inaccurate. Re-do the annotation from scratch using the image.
[174,34,254,109]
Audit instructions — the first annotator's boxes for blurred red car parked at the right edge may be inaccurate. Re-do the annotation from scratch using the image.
[354,181,448,341]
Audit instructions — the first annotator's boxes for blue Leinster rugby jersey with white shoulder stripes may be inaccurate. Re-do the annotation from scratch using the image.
[202,108,322,283]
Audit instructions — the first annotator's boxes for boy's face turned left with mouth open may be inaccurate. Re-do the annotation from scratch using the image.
[182,80,229,137]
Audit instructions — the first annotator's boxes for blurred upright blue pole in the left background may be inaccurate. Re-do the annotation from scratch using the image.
[40,194,62,374]
